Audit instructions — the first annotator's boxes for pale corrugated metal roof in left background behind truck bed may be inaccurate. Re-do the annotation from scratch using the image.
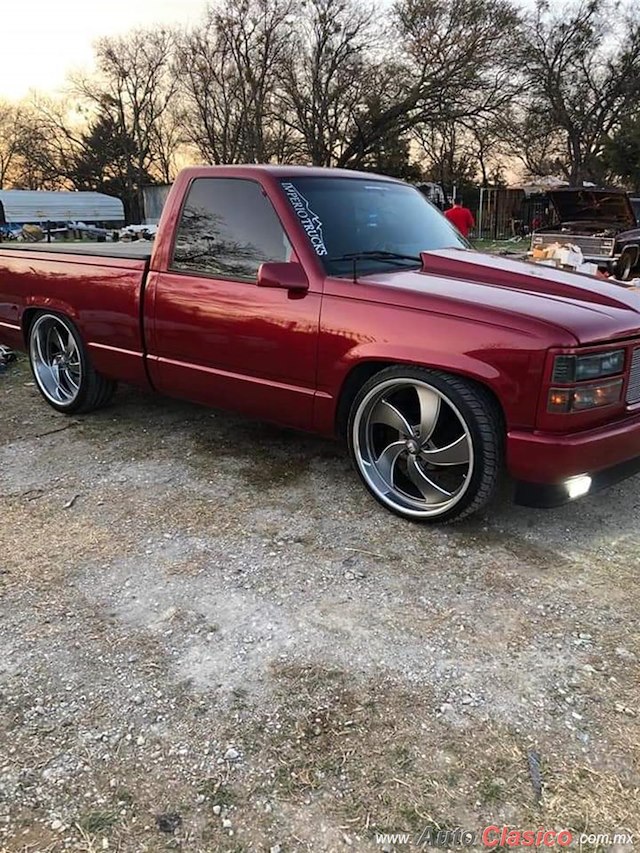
[0,190,124,224]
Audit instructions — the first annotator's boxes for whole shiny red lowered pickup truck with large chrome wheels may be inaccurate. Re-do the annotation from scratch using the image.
[0,166,640,521]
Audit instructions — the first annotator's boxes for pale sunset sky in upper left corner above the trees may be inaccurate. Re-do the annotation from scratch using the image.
[0,0,206,99]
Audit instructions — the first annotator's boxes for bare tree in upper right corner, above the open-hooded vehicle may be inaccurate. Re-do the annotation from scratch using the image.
[512,0,640,183]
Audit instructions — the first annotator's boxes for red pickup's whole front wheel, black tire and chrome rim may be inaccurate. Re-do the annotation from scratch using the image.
[348,366,504,523]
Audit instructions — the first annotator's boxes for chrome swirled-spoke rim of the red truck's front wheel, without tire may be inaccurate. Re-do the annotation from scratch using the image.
[352,379,474,518]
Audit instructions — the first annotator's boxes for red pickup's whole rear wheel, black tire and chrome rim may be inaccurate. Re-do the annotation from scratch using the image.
[29,311,116,414]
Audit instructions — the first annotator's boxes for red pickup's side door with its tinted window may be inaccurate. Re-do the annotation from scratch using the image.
[145,178,321,428]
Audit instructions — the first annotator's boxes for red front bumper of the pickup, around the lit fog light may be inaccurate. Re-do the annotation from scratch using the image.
[507,412,640,507]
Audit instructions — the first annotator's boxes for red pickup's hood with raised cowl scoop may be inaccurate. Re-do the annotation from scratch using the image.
[363,249,640,345]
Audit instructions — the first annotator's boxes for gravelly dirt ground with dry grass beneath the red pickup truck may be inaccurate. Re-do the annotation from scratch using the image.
[0,358,640,853]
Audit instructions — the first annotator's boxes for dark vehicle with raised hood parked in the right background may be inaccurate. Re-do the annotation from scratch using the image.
[531,187,640,281]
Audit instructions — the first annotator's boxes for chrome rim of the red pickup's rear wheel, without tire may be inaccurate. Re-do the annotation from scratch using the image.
[30,314,82,407]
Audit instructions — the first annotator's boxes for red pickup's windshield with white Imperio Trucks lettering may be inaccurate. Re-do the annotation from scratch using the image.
[281,177,469,275]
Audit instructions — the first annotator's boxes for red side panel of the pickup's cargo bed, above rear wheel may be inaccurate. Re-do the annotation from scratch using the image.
[0,246,149,385]
